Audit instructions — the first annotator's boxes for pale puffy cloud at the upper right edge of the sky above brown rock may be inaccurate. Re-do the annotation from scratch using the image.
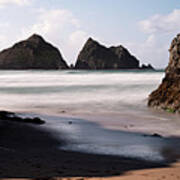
[139,9,180,34]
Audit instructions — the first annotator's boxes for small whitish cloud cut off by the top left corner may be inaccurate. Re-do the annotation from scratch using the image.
[0,0,31,8]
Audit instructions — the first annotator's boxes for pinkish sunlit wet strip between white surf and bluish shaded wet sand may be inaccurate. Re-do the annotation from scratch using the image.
[10,106,180,137]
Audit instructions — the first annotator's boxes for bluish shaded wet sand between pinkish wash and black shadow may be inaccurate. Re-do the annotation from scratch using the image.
[3,113,180,163]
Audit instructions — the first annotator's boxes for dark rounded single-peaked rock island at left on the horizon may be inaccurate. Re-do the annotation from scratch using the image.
[0,34,68,69]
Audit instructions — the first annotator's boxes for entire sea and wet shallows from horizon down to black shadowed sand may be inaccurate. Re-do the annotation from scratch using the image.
[0,70,180,161]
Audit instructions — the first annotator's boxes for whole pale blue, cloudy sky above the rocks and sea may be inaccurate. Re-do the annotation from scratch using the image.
[0,0,180,68]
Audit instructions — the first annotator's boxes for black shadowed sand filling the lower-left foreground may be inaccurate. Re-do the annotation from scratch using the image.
[0,121,167,178]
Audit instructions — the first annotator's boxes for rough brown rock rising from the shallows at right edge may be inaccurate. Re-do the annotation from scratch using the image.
[148,34,180,113]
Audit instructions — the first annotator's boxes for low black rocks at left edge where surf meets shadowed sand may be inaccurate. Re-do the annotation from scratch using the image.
[0,111,45,125]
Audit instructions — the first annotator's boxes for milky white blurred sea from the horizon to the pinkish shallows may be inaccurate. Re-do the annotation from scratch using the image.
[0,71,164,113]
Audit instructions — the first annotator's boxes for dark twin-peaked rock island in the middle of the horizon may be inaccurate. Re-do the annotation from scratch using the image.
[75,38,139,69]
